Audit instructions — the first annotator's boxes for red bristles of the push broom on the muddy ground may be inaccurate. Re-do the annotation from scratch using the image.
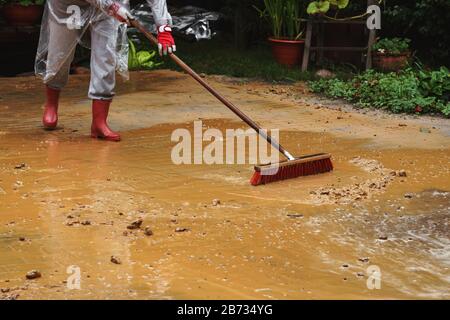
[250,158,333,186]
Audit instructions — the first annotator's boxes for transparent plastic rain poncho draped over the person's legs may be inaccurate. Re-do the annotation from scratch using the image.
[35,0,129,83]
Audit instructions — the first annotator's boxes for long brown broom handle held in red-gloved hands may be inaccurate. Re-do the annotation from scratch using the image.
[130,19,295,160]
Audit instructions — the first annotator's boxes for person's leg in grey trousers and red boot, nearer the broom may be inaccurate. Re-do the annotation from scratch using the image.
[89,16,120,141]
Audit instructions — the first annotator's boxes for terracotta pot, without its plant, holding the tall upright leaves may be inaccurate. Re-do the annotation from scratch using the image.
[269,38,305,67]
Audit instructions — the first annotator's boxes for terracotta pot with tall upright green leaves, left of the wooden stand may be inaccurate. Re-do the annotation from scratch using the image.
[257,0,305,67]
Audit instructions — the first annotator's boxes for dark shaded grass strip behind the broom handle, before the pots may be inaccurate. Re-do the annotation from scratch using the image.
[137,38,314,82]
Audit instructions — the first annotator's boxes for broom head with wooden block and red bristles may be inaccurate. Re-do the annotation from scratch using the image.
[250,153,333,186]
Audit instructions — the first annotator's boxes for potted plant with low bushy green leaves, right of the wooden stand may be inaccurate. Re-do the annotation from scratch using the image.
[372,38,411,72]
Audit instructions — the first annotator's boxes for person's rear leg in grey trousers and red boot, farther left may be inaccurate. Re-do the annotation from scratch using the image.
[42,20,78,129]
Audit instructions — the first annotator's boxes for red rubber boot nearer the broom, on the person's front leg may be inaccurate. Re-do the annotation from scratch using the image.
[91,100,120,141]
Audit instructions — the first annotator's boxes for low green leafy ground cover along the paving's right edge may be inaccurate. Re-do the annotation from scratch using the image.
[309,67,450,117]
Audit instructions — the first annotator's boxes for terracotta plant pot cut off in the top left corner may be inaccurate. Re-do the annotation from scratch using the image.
[0,0,45,26]
